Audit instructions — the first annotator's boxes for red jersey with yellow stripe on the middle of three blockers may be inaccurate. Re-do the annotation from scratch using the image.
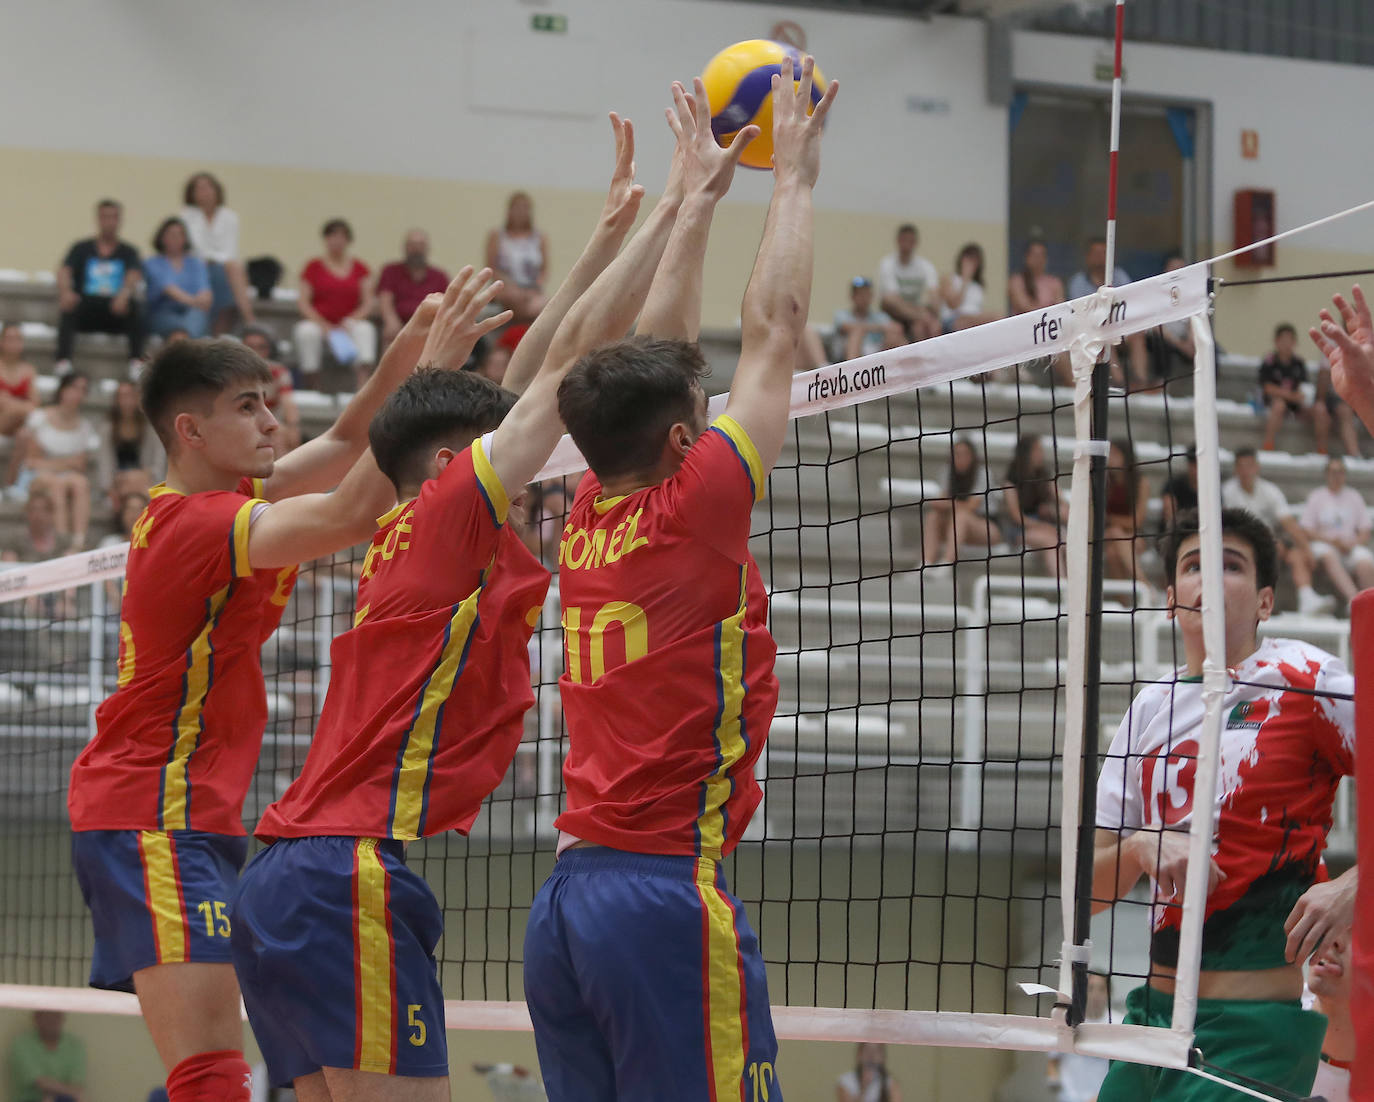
[256,437,548,841]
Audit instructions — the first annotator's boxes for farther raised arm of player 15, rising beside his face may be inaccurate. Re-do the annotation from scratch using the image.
[265,267,510,502]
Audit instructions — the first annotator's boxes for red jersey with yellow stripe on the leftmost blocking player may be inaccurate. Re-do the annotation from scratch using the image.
[67,478,295,834]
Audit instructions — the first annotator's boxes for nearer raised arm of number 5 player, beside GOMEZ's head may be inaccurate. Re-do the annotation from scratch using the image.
[492,109,683,488]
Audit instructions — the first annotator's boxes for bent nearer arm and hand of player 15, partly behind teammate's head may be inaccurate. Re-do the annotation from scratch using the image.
[249,268,508,570]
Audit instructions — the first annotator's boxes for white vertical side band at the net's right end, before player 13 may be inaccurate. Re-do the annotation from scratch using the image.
[1172,313,1227,1035]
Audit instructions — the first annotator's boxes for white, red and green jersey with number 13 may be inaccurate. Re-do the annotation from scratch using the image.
[1098,639,1355,971]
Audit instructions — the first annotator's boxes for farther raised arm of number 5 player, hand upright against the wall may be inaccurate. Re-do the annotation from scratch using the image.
[502,111,643,394]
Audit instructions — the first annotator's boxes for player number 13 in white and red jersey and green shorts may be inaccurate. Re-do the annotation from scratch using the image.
[1092,510,1356,1102]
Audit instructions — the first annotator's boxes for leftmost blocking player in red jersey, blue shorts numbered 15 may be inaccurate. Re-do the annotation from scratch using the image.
[67,268,500,1102]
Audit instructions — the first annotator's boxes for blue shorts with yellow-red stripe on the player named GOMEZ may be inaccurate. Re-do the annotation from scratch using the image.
[525,848,782,1102]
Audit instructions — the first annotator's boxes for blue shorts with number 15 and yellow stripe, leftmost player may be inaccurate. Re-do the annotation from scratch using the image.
[71,830,249,991]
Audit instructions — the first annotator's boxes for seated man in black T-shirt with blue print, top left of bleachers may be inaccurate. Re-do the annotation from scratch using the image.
[55,199,143,375]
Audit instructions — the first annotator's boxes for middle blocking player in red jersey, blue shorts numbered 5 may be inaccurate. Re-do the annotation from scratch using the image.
[232,115,708,1102]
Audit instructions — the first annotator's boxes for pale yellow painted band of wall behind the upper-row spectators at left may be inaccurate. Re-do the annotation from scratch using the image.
[0,148,1006,340]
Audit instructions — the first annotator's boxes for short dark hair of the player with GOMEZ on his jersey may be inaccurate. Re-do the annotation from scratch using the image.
[558,337,709,481]
